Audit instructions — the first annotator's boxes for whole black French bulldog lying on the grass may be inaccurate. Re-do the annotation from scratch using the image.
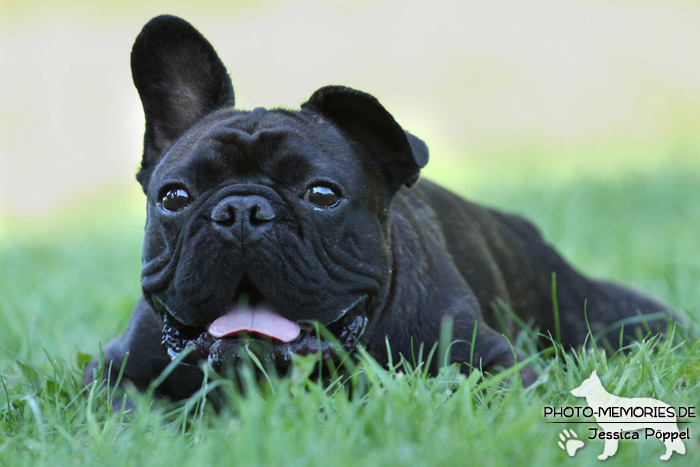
[85,16,666,398]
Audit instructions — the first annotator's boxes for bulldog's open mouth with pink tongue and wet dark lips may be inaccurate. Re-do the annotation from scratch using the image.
[150,278,369,369]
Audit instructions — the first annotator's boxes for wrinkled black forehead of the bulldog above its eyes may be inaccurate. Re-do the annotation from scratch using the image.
[153,108,362,190]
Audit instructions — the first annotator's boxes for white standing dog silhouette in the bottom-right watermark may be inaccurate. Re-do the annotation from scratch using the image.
[571,371,685,460]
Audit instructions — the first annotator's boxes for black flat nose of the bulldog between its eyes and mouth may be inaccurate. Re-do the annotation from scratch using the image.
[211,195,275,240]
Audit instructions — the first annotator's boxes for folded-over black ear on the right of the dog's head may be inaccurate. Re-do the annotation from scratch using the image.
[301,86,428,193]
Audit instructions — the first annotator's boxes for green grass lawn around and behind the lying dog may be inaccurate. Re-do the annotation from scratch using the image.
[0,156,700,465]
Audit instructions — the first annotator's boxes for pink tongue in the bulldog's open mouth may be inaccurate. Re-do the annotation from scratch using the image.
[207,305,301,342]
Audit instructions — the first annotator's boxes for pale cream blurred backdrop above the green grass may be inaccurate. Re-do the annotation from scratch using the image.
[0,0,700,217]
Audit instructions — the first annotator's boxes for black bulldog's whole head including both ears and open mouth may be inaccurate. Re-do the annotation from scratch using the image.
[132,16,427,365]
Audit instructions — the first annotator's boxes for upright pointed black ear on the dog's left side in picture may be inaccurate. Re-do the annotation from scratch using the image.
[131,15,234,192]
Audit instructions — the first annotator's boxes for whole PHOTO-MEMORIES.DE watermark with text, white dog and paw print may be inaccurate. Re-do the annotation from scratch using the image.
[543,371,697,460]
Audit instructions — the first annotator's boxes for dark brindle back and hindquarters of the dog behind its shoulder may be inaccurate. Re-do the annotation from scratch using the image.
[406,180,667,347]
